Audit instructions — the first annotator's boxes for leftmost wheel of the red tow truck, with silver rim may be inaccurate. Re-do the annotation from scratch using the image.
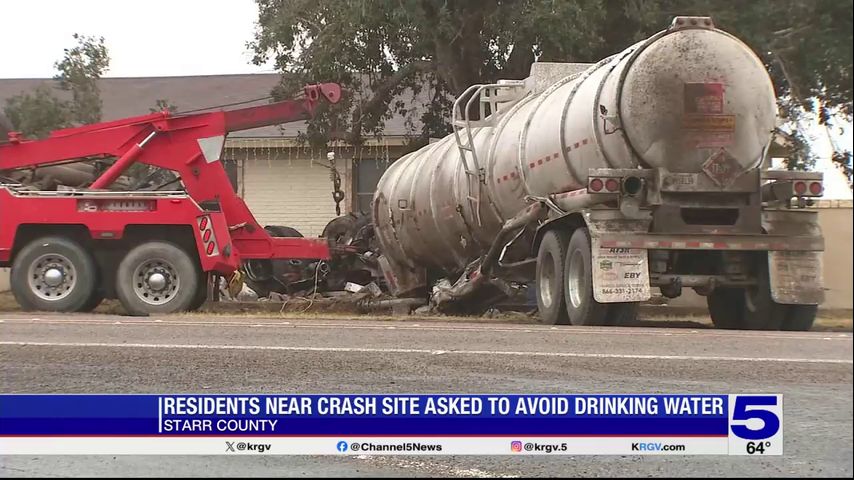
[10,236,98,312]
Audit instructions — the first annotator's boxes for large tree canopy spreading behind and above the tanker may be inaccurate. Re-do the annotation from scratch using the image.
[250,0,854,183]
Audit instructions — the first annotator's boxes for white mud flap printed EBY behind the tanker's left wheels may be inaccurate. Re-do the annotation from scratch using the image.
[591,237,650,303]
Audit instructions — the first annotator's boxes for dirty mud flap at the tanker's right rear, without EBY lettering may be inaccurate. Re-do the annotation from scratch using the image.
[768,251,824,305]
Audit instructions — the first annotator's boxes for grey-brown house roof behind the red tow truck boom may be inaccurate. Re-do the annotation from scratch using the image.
[0,73,422,138]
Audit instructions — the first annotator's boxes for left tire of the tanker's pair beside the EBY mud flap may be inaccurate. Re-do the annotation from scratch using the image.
[537,230,569,325]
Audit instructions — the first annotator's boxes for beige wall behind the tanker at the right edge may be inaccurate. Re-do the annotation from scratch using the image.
[668,200,854,310]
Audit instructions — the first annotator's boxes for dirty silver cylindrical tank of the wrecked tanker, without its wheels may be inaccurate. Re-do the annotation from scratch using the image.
[374,17,788,306]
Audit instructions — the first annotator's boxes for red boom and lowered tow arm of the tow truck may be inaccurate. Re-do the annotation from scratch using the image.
[0,83,348,258]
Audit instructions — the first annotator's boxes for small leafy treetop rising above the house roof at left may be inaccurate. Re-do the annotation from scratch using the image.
[54,33,110,124]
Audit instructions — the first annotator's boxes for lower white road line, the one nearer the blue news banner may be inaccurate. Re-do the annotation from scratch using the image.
[0,342,854,365]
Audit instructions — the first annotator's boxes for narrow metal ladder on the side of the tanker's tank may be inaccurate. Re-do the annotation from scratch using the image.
[451,80,525,227]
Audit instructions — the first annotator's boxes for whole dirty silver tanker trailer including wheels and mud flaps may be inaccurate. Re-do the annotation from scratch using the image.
[373,17,824,330]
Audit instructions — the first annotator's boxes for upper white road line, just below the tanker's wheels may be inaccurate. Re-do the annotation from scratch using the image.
[0,318,852,340]
